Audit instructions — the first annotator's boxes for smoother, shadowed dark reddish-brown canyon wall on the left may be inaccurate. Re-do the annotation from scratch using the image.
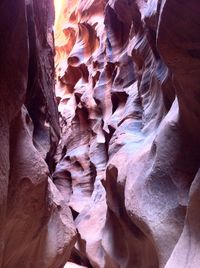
[0,0,76,268]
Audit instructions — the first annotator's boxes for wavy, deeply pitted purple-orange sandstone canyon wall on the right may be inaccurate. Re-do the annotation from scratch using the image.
[53,0,200,268]
